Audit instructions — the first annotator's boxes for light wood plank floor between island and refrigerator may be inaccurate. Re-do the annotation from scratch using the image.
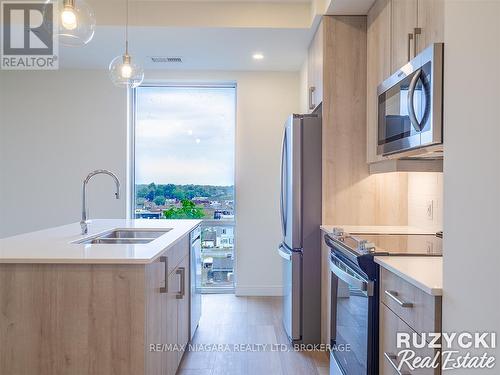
[178,294,329,375]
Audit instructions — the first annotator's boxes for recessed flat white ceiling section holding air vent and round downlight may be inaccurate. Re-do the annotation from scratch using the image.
[60,27,312,71]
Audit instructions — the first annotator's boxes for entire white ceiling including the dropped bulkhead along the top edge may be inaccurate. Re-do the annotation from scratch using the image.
[60,0,374,71]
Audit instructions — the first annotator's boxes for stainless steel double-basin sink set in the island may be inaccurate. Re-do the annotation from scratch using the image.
[73,228,172,245]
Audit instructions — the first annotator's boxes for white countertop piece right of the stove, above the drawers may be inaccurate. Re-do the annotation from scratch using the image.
[375,256,443,296]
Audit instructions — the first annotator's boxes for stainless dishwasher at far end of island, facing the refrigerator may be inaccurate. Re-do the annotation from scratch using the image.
[189,226,201,339]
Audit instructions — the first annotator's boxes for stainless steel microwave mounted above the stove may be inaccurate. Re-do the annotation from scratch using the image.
[377,43,443,156]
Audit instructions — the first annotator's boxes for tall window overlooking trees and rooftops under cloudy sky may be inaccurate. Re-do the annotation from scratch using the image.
[132,86,236,291]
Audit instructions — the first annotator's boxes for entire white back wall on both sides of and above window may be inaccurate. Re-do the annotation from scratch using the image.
[0,70,299,295]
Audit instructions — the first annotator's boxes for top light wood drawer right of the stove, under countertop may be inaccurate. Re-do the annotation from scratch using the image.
[380,268,441,333]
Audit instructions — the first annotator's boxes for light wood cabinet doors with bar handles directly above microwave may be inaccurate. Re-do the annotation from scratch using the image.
[391,0,444,71]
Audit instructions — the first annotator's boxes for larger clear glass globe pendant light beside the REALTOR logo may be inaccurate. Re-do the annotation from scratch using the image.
[58,0,96,47]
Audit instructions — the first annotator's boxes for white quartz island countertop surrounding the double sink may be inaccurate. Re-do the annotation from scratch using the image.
[0,219,201,264]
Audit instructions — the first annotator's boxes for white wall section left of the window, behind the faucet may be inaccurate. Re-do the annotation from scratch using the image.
[0,71,127,237]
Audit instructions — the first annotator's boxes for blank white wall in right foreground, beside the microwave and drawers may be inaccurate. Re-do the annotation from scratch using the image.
[443,0,500,374]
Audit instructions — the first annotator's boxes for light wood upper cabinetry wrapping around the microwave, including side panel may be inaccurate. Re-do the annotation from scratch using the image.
[366,0,444,168]
